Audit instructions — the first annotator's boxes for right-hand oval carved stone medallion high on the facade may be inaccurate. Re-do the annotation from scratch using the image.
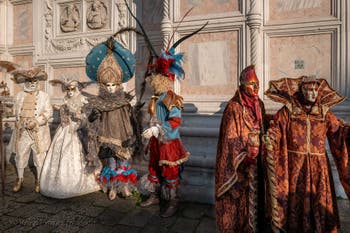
[86,0,108,30]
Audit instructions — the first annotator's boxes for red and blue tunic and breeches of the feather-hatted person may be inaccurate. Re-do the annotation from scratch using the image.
[148,90,189,188]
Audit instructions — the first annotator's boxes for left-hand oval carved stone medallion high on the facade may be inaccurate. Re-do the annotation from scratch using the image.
[60,4,80,32]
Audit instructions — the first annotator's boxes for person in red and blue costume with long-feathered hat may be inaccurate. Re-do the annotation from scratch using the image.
[124,1,208,217]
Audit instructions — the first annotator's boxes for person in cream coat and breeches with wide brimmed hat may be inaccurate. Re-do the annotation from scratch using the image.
[10,68,52,192]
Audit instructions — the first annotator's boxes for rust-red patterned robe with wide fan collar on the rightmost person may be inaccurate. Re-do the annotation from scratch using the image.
[265,77,350,233]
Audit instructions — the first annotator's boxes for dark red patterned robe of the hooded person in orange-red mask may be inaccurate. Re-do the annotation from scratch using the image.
[215,91,264,233]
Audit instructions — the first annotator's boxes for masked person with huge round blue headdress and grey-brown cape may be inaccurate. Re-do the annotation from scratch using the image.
[86,37,137,200]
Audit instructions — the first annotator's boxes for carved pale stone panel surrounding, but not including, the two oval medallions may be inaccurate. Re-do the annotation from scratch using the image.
[33,0,135,66]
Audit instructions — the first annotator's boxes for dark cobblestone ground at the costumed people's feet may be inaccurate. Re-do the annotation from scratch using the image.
[0,169,350,233]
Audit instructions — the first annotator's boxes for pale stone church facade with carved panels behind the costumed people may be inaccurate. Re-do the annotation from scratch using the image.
[0,0,350,203]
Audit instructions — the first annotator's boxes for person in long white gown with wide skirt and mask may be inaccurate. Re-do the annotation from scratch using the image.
[40,80,101,199]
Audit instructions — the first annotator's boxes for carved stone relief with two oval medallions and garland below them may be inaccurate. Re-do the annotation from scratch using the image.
[42,0,128,54]
